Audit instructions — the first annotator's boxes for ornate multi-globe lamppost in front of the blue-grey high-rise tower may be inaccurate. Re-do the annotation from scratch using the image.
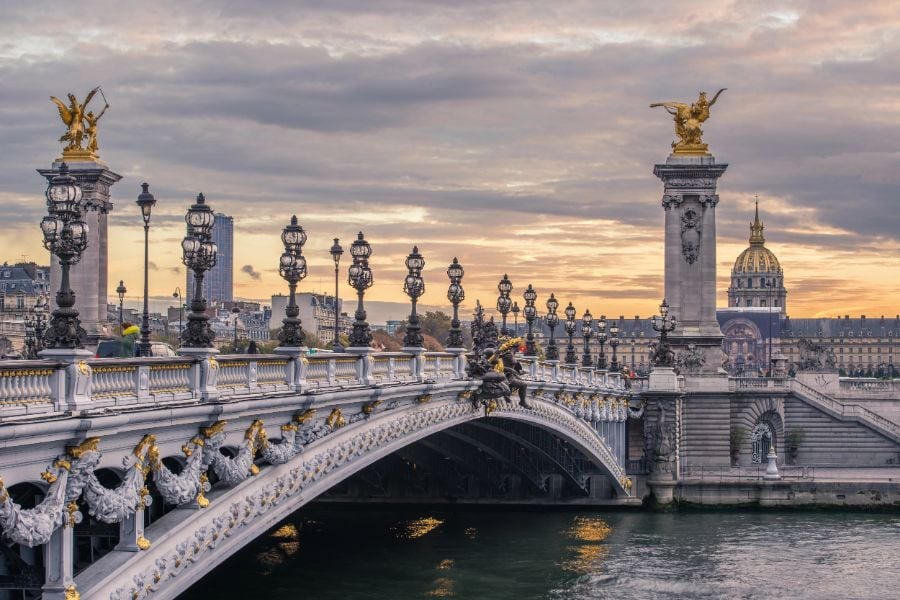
[181,194,219,348]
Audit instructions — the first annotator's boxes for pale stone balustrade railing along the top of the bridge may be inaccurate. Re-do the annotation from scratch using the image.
[0,352,625,417]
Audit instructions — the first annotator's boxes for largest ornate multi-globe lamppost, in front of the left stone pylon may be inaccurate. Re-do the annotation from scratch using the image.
[41,163,88,349]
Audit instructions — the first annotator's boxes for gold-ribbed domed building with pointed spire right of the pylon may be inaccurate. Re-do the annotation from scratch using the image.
[728,202,787,315]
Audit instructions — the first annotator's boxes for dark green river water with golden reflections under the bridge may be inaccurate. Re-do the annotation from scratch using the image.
[182,505,900,600]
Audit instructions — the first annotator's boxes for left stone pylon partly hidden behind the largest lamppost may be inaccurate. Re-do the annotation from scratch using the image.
[38,159,121,345]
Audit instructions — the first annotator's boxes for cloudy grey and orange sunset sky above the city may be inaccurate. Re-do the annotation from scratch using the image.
[0,0,900,317]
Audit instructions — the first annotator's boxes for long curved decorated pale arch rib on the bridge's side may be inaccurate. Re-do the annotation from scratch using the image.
[76,397,628,600]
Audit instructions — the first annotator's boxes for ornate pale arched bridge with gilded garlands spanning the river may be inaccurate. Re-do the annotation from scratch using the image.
[0,349,641,600]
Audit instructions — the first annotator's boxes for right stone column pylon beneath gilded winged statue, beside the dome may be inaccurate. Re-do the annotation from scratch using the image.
[653,154,728,374]
